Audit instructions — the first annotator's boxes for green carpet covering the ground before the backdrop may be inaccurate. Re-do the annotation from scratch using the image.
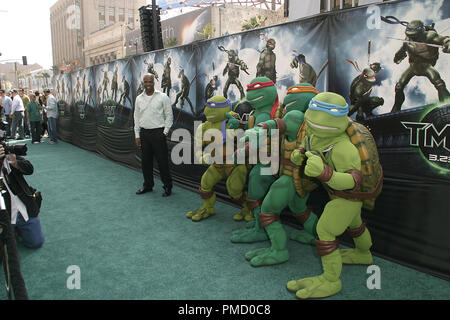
[0,142,450,300]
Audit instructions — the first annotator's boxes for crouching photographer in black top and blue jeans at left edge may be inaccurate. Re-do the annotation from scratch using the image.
[0,145,45,249]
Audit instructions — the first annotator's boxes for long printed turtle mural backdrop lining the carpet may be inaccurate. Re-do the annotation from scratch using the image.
[53,0,450,279]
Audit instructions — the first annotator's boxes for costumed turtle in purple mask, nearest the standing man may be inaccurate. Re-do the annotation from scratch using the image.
[186,96,253,221]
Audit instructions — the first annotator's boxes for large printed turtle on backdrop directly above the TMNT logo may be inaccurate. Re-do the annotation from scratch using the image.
[391,20,450,112]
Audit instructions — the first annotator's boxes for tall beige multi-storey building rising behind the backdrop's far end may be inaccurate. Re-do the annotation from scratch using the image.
[50,0,146,71]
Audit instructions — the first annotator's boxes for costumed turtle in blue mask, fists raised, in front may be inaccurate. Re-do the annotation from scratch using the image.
[287,92,383,299]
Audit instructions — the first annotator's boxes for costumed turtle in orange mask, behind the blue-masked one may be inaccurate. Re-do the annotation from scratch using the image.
[232,83,318,267]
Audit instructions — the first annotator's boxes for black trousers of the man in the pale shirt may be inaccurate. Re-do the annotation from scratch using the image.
[140,128,172,189]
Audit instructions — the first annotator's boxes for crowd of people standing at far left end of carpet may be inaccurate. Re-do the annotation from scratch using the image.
[0,88,58,144]
